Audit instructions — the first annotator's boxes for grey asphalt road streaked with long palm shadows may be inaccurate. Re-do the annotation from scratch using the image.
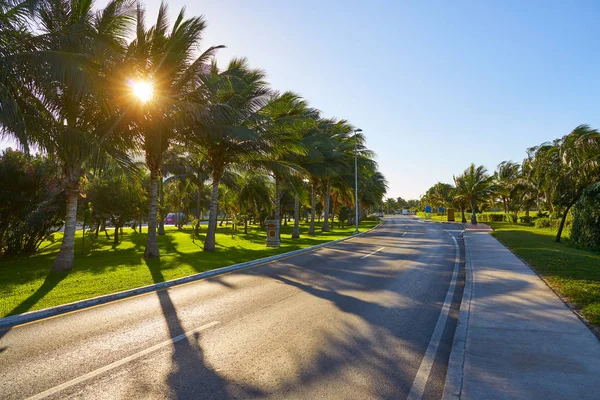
[0,217,464,399]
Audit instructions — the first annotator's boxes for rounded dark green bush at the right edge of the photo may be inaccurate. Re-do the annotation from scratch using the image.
[571,183,600,248]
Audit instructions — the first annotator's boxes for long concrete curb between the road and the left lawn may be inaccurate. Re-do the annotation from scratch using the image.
[0,221,383,329]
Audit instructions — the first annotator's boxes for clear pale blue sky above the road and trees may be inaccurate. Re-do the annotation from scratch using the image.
[0,0,600,199]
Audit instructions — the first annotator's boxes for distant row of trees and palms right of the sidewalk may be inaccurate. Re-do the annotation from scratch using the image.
[421,125,600,242]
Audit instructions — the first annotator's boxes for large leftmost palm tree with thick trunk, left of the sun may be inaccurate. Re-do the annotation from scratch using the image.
[0,0,133,271]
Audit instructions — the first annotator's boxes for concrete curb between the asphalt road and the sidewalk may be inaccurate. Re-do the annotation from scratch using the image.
[442,231,473,400]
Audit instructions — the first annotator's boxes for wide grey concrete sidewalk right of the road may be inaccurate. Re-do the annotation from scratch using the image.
[444,230,600,400]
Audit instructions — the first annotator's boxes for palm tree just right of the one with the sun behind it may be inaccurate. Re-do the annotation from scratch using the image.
[187,59,282,251]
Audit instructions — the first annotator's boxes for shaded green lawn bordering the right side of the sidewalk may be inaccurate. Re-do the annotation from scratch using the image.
[489,222,600,327]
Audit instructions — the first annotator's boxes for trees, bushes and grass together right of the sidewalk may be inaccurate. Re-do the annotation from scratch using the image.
[404,125,600,327]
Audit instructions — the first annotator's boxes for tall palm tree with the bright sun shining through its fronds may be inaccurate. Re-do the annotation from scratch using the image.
[127,2,223,258]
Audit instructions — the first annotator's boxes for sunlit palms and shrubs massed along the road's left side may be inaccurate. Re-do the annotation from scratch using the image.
[0,0,387,282]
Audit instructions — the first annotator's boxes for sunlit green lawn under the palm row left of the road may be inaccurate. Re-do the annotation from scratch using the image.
[0,221,377,317]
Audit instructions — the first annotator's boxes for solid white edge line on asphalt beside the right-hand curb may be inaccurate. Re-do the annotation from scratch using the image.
[407,229,460,400]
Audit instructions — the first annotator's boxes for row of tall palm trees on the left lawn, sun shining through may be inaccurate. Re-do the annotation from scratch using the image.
[0,0,386,271]
